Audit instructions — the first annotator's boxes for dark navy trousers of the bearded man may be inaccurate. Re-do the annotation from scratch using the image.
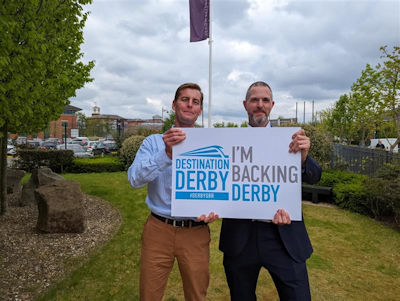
[224,221,311,301]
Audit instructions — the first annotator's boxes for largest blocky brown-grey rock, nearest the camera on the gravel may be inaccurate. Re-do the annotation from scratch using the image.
[35,180,86,233]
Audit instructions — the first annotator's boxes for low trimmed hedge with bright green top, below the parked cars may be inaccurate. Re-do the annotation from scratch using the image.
[67,156,124,173]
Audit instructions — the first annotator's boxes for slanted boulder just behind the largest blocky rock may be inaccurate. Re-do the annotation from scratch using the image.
[20,167,64,206]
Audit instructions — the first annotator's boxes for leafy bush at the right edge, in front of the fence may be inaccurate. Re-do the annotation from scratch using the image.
[364,164,400,224]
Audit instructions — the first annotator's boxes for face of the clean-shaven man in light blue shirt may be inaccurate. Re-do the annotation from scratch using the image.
[172,88,202,127]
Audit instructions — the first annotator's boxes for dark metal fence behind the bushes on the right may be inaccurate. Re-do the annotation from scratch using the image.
[331,144,400,176]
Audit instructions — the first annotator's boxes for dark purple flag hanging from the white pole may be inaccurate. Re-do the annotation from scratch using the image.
[189,0,210,42]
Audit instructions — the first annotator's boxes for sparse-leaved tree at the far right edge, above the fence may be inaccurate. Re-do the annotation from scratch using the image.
[376,46,400,151]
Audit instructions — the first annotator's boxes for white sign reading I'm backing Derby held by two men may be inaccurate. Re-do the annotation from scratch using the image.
[172,127,302,221]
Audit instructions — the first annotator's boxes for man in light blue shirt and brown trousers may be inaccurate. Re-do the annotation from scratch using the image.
[128,83,218,301]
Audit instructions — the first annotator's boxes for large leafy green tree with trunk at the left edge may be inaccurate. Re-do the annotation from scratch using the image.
[0,0,94,214]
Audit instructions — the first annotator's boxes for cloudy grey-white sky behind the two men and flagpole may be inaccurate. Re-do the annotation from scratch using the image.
[71,0,400,126]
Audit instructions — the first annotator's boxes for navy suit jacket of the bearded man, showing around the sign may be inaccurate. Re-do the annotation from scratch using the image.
[219,156,321,262]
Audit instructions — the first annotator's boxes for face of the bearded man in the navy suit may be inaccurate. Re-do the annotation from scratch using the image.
[243,86,275,127]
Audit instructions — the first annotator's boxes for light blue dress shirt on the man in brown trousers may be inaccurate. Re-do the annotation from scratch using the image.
[128,134,195,220]
